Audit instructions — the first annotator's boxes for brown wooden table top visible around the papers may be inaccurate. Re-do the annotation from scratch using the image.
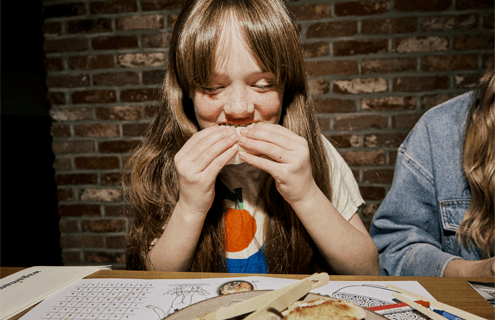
[0,267,495,320]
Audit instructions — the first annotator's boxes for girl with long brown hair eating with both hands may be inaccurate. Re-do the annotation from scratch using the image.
[124,0,378,274]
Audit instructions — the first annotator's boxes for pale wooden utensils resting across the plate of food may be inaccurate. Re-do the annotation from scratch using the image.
[203,273,330,320]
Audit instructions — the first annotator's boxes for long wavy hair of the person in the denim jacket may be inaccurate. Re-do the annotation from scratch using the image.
[457,62,495,258]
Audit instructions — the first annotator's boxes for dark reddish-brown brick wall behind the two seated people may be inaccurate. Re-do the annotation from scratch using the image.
[43,0,494,268]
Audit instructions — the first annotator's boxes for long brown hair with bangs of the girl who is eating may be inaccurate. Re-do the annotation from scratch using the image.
[123,0,331,273]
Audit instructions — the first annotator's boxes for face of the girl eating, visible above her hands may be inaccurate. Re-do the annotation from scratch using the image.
[192,24,283,129]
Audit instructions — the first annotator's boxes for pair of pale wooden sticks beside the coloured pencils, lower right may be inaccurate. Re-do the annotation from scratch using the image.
[387,284,486,320]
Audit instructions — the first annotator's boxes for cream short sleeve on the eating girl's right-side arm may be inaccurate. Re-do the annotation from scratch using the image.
[322,136,364,221]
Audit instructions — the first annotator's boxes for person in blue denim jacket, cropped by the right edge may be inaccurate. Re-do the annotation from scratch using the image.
[370,64,495,277]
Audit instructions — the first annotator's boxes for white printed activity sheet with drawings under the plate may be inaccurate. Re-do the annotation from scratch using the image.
[21,277,433,320]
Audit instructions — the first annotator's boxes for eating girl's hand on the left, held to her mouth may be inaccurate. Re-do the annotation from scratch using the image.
[174,126,238,215]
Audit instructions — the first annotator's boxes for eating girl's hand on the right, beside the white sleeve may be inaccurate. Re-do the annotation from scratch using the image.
[239,123,318,205]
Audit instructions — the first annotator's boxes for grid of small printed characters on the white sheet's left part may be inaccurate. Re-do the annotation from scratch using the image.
[39,280,153,320]
